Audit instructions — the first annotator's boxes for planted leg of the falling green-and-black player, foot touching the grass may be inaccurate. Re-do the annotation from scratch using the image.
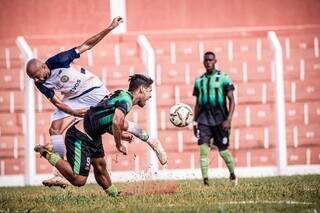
[92,158,119,197]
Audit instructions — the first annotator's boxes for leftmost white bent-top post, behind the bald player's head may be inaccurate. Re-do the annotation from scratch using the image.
[16,36,36,185]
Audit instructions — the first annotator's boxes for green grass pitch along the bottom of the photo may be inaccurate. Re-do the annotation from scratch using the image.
[0,175,320,212]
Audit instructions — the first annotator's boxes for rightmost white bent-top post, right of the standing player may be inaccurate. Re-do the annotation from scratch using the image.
[268,31,287,175]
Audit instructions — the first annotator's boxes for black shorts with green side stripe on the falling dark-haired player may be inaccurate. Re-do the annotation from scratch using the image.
[65,124,104,176]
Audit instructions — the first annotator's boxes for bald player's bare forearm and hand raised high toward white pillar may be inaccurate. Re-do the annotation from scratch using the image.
[77,16,123,54]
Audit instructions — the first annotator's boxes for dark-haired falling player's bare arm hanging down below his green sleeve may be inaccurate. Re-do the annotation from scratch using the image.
[112,108,127,155]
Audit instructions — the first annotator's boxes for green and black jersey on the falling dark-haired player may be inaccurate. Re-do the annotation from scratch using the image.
[84,90,133,138]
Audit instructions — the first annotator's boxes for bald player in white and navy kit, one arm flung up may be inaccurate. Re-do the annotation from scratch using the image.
[27,17,123,187]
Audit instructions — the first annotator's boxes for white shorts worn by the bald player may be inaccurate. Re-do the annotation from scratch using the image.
[51,86,109,121]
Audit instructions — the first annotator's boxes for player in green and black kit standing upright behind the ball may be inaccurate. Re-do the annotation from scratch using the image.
[193,52,237,186]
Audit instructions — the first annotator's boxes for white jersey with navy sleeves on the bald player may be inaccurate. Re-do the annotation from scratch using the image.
[36,48,103,100]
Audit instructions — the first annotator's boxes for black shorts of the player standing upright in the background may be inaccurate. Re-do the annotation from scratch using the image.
[198,124,230,151]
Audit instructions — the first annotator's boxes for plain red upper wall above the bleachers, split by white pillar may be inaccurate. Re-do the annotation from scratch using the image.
[0,0,320,38]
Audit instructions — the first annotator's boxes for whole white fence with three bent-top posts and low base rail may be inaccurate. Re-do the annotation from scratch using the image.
[0,32,320,186]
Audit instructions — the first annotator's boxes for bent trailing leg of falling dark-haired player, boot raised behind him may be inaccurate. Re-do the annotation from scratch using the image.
[34,145,87,188]
